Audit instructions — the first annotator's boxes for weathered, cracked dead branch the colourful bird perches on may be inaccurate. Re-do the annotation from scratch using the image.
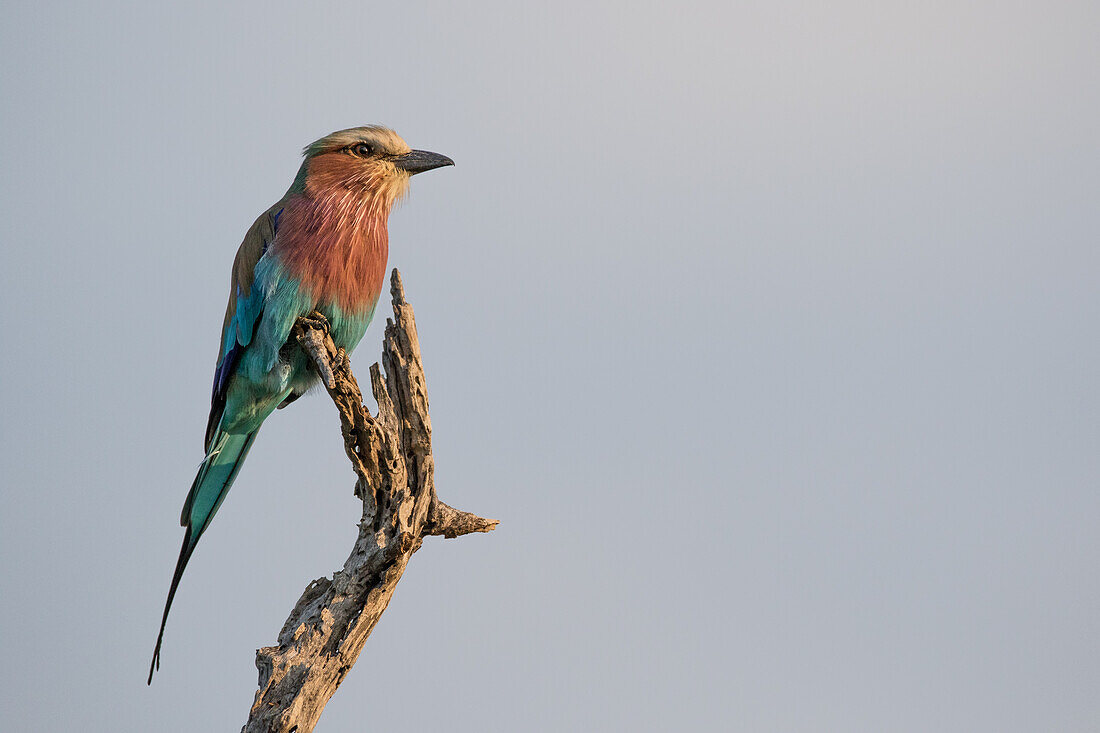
[242,270,497,733]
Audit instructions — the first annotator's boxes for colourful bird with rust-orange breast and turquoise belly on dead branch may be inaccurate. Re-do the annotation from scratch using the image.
[146,125,454,685]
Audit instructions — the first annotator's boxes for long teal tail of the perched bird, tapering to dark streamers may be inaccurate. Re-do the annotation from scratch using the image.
[146,430,256,685]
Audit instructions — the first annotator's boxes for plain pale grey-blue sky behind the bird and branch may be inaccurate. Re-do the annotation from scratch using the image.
[0,1,1100,733]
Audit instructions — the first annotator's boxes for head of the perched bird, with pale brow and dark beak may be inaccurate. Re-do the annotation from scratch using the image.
[292,125,454,209]
